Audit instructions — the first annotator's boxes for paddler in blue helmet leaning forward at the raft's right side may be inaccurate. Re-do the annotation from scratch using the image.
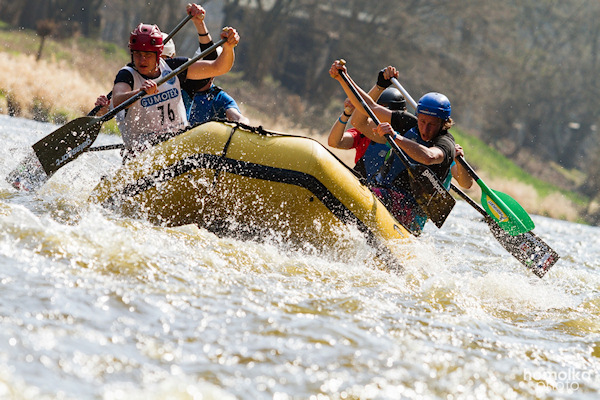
[329,61,470,234]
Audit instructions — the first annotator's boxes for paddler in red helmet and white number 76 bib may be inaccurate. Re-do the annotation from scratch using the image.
[101,4,240,159]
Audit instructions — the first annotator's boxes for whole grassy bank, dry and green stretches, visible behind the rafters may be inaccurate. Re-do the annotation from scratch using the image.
[0,25,589,222]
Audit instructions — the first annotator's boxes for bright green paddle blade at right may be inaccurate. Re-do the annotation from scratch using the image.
[481,189,535,236]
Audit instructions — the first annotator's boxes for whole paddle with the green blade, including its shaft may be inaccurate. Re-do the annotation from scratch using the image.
[391,78,535,236]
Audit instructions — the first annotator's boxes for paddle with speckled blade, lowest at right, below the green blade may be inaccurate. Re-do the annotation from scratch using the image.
[450,184,560,278]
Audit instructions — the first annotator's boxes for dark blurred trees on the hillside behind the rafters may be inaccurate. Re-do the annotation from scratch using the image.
[0,0,600,206]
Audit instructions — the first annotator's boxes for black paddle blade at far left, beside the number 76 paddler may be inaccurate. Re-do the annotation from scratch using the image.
[32,116,102,176]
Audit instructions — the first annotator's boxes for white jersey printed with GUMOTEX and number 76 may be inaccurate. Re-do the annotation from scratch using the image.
[112,59,188,150]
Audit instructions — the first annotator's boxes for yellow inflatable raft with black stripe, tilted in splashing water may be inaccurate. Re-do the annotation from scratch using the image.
[90,121,409,266]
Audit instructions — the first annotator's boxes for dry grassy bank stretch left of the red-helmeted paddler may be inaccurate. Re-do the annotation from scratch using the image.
[0,21,129,130]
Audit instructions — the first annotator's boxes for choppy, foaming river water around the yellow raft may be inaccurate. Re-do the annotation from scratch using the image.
[0,116,600,400]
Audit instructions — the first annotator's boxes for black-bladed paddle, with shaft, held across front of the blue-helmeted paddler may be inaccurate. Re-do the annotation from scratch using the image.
[339,62,456,228]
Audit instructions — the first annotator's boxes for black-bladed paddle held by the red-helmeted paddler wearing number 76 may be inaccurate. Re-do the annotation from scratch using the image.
[22,38,227,177]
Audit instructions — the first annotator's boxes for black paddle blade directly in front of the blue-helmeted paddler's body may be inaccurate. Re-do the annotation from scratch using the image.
[408,164,456,228]
